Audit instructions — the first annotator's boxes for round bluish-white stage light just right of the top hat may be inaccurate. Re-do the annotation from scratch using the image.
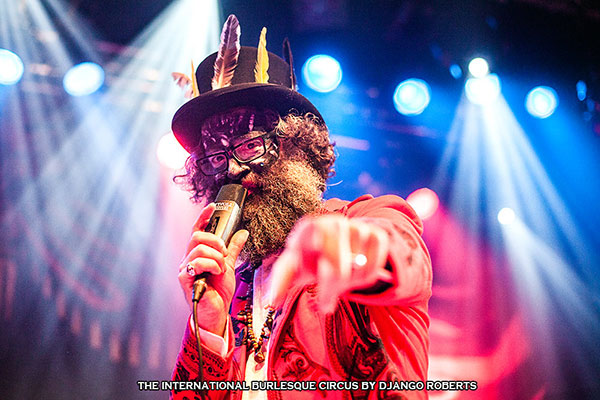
[302,54,342,93]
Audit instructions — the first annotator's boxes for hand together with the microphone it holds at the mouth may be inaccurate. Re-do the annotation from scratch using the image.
[179,184,248,335]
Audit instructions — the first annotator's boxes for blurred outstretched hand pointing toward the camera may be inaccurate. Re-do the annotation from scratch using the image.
[271,214,391,312]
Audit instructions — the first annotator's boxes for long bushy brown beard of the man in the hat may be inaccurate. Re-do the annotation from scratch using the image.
[242,159,323,263]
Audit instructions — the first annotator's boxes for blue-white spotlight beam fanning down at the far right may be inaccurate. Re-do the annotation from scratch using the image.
[432,90,597,396]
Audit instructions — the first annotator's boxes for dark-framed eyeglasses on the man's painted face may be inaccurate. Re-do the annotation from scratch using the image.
[196,131,276,176]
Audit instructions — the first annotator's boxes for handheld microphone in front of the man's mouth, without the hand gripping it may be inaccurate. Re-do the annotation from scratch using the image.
[192,183,247,302]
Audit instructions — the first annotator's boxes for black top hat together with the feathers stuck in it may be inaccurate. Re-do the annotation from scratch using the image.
[171,15,323,152]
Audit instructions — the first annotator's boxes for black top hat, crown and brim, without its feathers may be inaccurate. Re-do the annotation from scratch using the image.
[172,17,323,152]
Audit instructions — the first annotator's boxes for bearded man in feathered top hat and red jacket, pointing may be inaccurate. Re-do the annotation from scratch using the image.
[171,16,432,399]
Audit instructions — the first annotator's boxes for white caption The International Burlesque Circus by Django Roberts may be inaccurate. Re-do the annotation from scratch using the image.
[137,381,477,391]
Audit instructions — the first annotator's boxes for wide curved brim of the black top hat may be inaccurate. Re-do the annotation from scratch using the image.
[171,82,324,152]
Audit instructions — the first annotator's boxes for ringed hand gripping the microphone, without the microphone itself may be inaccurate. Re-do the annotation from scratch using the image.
[179,203,248,336]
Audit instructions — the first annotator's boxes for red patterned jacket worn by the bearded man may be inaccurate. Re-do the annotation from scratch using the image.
[171,195,432,400]
